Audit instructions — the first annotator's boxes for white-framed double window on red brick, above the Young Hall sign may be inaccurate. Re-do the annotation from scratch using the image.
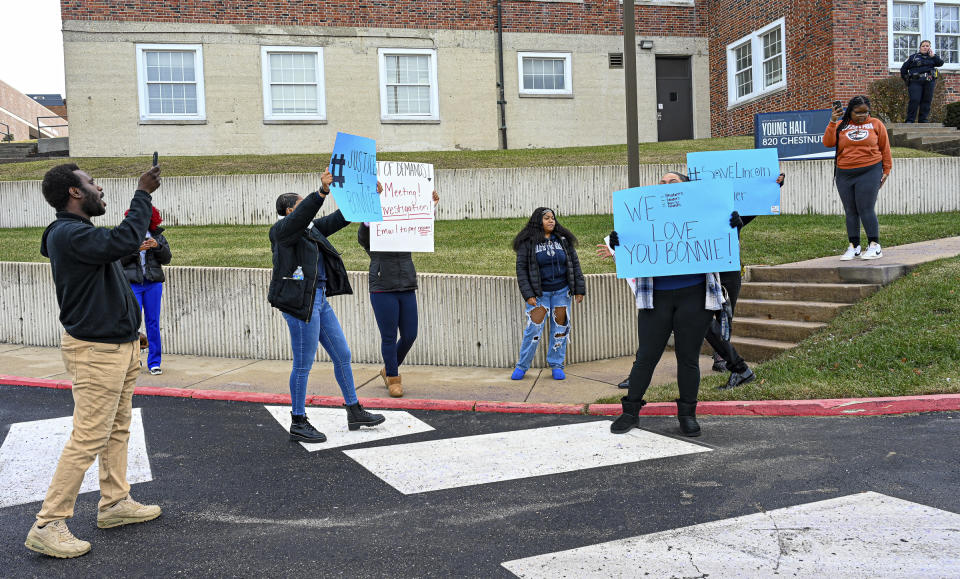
[727,18,787,105]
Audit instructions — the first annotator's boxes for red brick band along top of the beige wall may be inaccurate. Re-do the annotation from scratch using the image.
[60,0,704,36]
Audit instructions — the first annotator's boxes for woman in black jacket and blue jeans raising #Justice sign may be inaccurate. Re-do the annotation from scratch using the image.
[267,171,384,442]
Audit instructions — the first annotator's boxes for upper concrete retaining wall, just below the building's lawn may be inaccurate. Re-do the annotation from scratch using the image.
[0,158,960,227]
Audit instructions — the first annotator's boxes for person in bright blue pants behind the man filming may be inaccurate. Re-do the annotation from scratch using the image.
[120,207,173,375]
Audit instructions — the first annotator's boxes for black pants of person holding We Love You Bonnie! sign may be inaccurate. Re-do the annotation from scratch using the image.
[627,283,713,403]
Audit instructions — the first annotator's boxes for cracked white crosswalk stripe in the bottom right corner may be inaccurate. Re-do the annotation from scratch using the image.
[503,492,960,579]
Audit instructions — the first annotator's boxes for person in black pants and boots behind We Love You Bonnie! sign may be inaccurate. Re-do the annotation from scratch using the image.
[597,172,724,436]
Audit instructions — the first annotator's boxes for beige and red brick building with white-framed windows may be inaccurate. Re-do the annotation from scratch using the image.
[61,0,960,155]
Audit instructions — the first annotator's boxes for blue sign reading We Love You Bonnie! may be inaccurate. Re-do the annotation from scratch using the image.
[613,181,740,278]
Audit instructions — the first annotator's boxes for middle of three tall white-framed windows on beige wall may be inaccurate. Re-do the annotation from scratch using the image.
[260,46,326,121]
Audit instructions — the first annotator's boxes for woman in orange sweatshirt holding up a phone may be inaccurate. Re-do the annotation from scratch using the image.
[823,95,893,261]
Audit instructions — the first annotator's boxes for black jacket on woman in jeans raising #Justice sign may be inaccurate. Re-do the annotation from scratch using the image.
[267,191,353,322]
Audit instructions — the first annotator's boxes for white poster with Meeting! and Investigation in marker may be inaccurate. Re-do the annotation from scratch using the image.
[370,161,435,252]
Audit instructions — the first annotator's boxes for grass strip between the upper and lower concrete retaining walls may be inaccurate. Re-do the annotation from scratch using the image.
[0,212,960,276]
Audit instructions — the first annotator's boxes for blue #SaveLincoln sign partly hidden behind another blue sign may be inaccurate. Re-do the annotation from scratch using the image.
[687,149,780,215]
